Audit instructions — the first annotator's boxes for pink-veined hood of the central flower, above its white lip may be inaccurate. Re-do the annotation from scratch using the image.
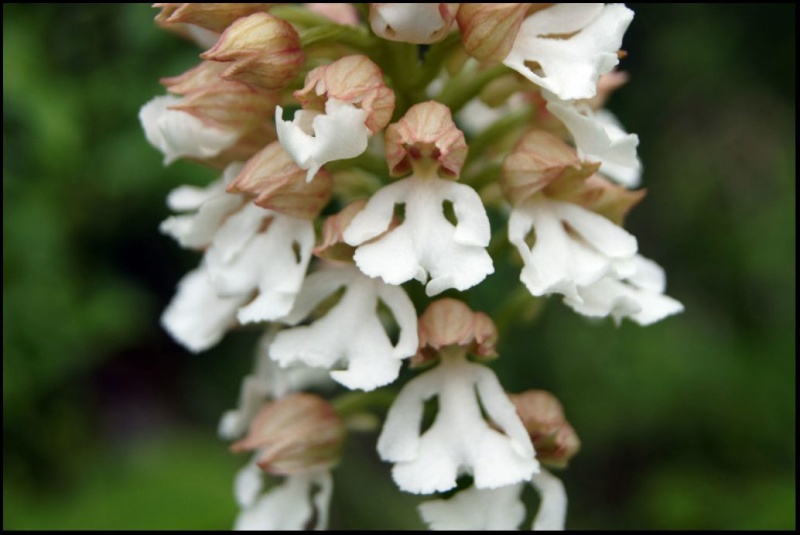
[386,100,467,180]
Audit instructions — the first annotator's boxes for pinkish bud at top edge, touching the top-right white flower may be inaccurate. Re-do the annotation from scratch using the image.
[456,4,530,61]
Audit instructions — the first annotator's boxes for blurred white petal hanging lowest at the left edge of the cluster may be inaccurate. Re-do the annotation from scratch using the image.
[161,266,247,353]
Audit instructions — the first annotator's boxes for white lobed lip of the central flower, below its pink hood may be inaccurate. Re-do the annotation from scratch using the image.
[344,175,494,296]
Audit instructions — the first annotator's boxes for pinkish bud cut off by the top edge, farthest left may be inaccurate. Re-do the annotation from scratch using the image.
[153,2,275,33]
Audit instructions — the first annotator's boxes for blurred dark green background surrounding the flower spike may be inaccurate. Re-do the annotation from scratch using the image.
[3,4,796,529]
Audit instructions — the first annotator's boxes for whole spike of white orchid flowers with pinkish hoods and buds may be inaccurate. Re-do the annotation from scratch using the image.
[140,3,682,529]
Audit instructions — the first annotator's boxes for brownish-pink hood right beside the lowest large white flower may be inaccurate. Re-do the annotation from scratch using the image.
[508,390,581,468]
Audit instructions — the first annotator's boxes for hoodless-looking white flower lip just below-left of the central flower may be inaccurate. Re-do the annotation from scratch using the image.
[270,267,417,390]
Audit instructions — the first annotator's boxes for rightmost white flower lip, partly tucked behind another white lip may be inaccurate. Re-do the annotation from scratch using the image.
[564,255,683,326]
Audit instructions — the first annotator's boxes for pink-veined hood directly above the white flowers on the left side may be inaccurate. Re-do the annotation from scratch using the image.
[228,141,333,220]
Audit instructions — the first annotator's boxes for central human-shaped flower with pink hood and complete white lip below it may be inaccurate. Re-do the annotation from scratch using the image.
[344,101,494,295]
